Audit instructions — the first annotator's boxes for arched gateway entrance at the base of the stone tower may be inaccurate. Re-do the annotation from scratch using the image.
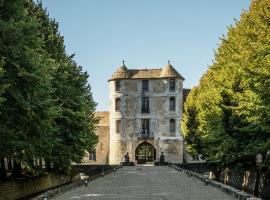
[135,142,156,164]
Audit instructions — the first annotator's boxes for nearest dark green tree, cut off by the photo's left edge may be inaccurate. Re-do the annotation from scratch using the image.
[0,1,55,176]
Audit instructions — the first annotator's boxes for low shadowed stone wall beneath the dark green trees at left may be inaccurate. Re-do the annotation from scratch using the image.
[0,174,71,200]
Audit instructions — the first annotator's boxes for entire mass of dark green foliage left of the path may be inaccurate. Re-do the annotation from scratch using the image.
[0,0,97,176]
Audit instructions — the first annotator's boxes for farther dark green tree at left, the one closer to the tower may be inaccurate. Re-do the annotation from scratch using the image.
[31,3,97,171]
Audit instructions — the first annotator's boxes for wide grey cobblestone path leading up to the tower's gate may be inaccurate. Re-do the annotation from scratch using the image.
[53,166,234,200]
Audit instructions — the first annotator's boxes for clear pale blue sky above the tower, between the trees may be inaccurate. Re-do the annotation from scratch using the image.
[42,0,250,111]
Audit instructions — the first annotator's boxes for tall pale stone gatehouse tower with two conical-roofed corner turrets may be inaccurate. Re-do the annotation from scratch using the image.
[109,62,184,164]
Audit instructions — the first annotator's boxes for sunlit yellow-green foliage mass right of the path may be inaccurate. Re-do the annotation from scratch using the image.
[182,0,270,170]
